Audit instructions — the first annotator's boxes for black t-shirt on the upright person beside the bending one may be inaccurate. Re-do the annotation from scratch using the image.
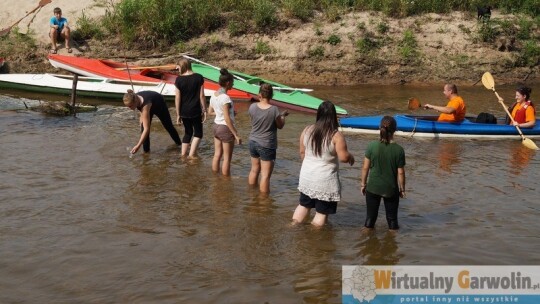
[174,73,204,118]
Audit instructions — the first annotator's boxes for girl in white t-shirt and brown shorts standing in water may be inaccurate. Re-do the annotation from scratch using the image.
[208,69,242,176]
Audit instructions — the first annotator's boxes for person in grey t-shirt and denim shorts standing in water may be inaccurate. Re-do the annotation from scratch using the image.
[248,83,289,193]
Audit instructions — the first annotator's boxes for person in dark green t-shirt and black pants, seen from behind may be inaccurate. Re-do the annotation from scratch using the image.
[360,116,405,230]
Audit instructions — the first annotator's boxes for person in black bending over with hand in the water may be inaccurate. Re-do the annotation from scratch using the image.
[123,90,182,154]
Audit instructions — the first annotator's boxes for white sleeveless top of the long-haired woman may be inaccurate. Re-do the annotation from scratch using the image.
[298,127,341,202]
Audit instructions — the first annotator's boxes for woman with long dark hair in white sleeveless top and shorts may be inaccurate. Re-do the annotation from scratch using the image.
[293,101,354,227]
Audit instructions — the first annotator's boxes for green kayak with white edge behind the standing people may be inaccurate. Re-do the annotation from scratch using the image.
[185,56,348,116]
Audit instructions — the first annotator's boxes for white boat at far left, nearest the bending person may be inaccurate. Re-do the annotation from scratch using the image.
[0,74,184,101]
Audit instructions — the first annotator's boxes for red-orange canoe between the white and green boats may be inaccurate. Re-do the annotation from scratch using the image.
[48,54,251,100]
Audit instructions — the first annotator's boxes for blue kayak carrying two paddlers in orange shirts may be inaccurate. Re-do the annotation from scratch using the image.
[340,114,540,139]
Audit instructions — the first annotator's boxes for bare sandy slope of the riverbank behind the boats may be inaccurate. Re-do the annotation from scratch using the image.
[0,0,540,85]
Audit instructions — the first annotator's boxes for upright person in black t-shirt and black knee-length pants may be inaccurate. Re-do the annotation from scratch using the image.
[174,58,206,158]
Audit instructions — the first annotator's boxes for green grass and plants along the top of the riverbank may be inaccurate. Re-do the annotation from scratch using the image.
[59,0,540,49]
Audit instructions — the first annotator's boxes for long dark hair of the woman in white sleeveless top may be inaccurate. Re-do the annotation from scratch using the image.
[308,101,339,156]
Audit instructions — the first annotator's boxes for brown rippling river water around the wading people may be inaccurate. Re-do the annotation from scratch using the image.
[0,84,540,303]
